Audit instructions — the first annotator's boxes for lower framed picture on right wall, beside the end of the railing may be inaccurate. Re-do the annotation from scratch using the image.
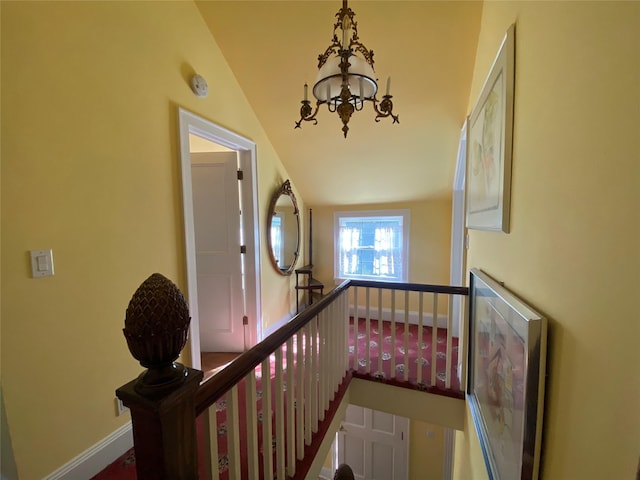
[467,269,547,480]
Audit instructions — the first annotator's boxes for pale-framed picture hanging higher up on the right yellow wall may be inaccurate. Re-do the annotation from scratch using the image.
[466,25,515,233]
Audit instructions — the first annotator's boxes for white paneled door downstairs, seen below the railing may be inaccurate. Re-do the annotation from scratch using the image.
[337,405,409,480]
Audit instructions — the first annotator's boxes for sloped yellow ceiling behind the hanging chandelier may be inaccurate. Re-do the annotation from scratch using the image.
[197,0,482,206]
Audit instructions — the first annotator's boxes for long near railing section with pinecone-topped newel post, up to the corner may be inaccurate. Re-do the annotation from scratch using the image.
[116,274,350,480]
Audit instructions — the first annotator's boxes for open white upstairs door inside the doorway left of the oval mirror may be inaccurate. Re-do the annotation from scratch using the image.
[191,152,245,352]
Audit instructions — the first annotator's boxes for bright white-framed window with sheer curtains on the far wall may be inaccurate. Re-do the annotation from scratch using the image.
[334,210,409,282]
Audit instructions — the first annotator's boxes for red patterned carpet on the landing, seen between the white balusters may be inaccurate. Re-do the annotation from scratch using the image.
[91,319,460,480]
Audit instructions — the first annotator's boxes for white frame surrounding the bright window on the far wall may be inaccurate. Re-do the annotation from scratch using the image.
[333,209,411,283]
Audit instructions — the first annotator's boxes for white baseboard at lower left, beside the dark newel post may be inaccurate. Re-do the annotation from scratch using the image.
[44,422,133,480]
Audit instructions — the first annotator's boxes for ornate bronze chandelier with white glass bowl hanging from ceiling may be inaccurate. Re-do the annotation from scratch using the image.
[295,0,400,138]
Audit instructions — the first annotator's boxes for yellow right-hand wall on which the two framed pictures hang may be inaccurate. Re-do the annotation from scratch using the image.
[455,2,640,480]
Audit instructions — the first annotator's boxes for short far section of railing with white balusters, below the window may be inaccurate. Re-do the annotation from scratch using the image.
[349,280,469,398]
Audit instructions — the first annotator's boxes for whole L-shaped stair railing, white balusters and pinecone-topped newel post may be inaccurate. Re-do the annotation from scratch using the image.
[116,274,468,480]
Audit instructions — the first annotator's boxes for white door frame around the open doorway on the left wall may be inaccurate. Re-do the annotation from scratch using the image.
[178,107,262,369]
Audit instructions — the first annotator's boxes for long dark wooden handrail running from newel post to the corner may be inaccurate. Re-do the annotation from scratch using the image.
[195,280,350,415]
